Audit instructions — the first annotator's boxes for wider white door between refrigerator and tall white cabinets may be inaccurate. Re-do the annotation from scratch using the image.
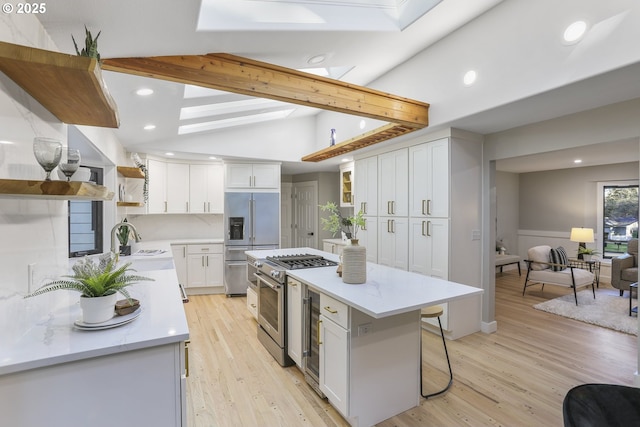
[293,181,318,248]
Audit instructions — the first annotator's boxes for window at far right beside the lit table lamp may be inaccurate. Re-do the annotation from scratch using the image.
[599,183,638,258]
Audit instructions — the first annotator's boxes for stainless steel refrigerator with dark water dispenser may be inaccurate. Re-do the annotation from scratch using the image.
[224,193,280,296]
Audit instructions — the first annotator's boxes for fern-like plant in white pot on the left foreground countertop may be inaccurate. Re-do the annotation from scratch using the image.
[25,252,153,323]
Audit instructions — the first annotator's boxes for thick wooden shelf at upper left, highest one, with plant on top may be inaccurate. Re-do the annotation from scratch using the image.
[0,42,119,128]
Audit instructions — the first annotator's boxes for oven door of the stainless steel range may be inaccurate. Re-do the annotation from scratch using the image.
[255,273,285,348]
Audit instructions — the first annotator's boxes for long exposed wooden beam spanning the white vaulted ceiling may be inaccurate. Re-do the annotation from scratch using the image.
[101,53,429,130]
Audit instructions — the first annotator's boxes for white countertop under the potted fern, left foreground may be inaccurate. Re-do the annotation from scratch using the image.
[0,270,189,375]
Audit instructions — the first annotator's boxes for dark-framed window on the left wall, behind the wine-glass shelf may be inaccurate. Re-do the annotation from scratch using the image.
[69,167,103,258]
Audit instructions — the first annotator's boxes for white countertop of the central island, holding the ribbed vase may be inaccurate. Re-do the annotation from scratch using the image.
[247,248,484,318]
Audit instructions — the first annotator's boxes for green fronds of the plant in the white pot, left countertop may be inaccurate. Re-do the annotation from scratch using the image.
[25,252,153,301]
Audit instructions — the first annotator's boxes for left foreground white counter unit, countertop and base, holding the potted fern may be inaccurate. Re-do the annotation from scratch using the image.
[0,252,189,427]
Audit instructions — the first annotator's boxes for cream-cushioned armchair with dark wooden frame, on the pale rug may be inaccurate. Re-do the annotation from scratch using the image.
[522,245,596,305]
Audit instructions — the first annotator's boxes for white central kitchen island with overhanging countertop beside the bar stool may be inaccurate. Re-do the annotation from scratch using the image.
[247,248,483,426]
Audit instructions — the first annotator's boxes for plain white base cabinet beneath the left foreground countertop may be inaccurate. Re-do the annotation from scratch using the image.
[0,344,188,427]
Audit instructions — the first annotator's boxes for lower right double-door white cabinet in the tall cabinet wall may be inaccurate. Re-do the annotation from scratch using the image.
[409,218,449,280]
